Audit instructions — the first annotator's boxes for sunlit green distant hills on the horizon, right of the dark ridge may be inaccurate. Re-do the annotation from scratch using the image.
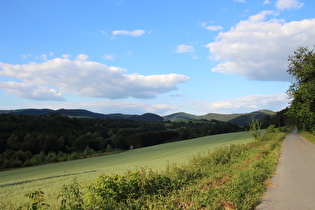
[164,110,276,126]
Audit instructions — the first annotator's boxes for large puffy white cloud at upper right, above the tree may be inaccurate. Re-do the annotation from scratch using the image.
[207,11,315,81]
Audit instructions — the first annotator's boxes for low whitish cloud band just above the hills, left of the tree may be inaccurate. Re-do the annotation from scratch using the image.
[192,93,289,114]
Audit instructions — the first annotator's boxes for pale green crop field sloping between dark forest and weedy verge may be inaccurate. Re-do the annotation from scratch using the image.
[0,132,252,208]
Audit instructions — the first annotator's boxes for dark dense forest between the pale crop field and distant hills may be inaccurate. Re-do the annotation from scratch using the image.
[0,113,243,169]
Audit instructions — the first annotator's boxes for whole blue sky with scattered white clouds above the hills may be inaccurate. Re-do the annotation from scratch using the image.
[0,0,315,116]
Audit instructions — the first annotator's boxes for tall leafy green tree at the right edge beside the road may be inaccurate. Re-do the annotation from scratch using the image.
[287,47,315,132]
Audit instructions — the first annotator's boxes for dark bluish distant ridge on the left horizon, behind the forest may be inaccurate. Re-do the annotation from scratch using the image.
[0,109,164,121]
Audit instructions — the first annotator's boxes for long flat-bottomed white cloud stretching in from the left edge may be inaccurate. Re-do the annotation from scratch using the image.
[0,54,189,100]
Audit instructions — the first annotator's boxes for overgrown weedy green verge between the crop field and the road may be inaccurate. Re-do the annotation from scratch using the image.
[16,129,287,209]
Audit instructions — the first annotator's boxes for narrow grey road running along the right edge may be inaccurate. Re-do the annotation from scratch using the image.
[256,131,315,210]
